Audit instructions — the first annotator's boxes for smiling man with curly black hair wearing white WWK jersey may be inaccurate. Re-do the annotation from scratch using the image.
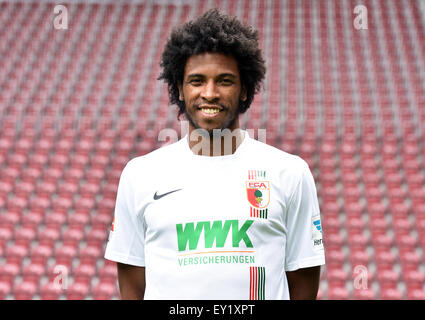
[105,10,325,300]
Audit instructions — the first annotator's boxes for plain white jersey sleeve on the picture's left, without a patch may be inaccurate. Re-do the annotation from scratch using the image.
[105,161,145,267]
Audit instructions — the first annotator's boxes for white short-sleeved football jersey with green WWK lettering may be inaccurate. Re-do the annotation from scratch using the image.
[105,132,325,300]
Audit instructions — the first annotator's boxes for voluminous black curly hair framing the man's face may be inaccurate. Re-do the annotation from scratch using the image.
[158,9,266,118]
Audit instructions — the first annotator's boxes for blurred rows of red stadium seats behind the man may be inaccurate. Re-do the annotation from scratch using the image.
[0,0,425,299]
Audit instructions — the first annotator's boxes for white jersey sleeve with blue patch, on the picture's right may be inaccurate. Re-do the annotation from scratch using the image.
[285,162,325,271]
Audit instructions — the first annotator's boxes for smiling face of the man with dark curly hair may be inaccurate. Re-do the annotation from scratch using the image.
[179,53,246,136]
